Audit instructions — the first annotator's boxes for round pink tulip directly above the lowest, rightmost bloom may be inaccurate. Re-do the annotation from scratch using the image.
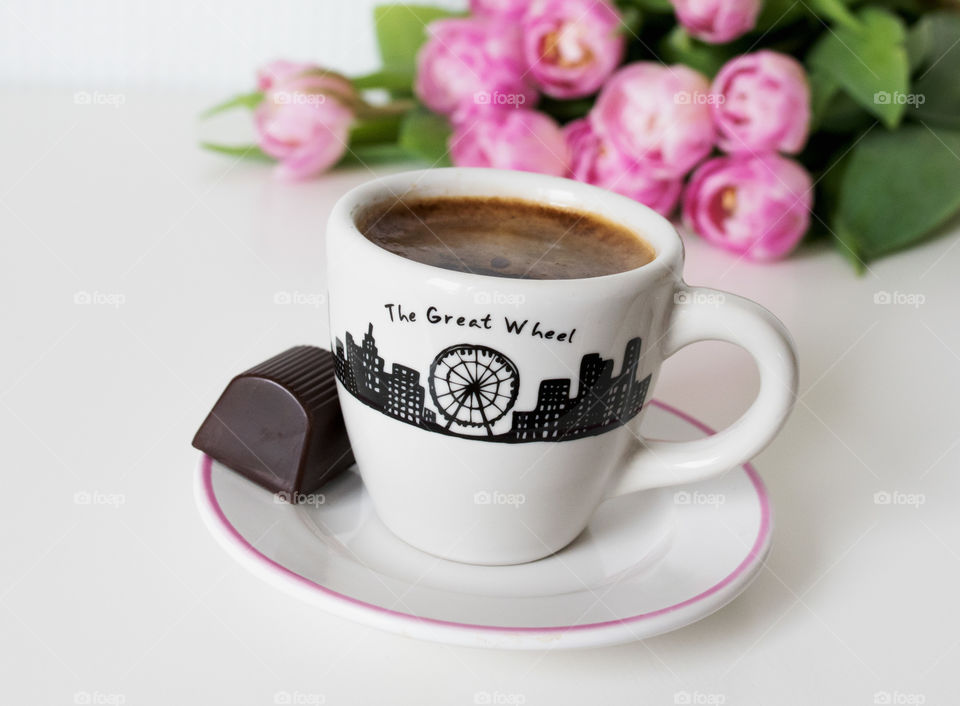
[710,50,810,154]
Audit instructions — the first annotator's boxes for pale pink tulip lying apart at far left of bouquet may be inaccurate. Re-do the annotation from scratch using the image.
[254,73,357,179]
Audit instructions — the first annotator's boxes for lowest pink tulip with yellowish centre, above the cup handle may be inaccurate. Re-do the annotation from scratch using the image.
[683,152,813,260]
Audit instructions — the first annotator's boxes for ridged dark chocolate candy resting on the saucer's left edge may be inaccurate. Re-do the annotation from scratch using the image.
[193,346,354,502]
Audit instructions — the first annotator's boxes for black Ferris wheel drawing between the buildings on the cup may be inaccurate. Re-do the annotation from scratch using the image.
[429,343,520,436]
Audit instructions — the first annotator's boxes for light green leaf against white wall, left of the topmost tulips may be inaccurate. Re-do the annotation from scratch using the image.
[373,4,458,82]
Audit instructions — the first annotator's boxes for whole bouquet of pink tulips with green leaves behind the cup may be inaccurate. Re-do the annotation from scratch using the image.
[205,0,960,267]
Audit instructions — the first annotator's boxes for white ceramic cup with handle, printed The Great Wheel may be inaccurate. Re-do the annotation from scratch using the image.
[327,168,797,564]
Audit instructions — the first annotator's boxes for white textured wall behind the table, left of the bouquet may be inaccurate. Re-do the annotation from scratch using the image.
[0,0,466,91]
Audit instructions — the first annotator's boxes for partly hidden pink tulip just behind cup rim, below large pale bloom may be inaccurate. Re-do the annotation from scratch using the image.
[563,118,683,216]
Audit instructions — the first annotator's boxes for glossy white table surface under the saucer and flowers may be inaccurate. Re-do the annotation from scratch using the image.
[0,90,960,706]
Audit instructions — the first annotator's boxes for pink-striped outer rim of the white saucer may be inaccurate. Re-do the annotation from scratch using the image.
[197,400,772,648]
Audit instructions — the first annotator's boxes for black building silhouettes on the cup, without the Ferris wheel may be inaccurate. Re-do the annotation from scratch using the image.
[334,324,650,443]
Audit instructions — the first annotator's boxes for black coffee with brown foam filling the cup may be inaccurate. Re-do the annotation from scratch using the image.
[357,197,655,279]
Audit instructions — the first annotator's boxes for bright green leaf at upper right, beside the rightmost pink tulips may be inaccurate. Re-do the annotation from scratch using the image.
[807,7,909,128]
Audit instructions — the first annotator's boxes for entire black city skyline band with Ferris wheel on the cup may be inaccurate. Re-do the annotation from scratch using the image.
[334,324,650,443]
